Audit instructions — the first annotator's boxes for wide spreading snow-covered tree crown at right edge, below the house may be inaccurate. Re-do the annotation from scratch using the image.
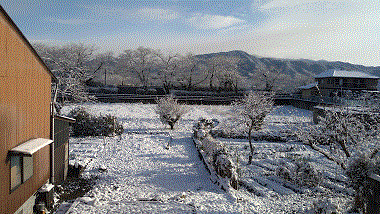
[295,107,380,170]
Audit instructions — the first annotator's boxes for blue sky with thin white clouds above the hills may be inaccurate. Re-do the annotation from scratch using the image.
[0,0,380,66]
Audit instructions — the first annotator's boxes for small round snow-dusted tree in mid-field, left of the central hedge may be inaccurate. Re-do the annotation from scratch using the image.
[156,95,186,129]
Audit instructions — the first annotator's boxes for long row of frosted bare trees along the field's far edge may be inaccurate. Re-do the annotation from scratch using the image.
[34,44,305,102]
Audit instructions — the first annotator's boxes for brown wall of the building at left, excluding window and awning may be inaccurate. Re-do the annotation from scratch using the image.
[0,11,51,213]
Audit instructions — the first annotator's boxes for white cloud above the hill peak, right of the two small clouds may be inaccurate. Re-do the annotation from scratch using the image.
[187,13,244,29]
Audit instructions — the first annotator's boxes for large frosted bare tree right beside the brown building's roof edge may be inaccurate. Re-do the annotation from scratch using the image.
[34,44,102,103]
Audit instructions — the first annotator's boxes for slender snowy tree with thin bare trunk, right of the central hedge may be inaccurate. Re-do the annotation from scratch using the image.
[232,91,274,164]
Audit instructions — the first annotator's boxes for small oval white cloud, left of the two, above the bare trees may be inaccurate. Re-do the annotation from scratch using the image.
[133,8,179,22]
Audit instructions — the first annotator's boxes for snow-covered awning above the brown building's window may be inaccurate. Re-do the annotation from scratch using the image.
[10,138,53,156]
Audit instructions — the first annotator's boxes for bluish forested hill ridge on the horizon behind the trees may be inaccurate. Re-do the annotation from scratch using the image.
[198,51,380,77]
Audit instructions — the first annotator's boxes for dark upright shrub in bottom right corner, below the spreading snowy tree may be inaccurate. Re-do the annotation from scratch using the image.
[346,154,379,213]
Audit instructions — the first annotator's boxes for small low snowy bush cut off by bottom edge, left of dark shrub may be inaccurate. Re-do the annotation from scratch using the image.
[305,198,342,214]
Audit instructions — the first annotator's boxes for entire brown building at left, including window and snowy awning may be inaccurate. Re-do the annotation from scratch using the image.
[0,6,56,213]
